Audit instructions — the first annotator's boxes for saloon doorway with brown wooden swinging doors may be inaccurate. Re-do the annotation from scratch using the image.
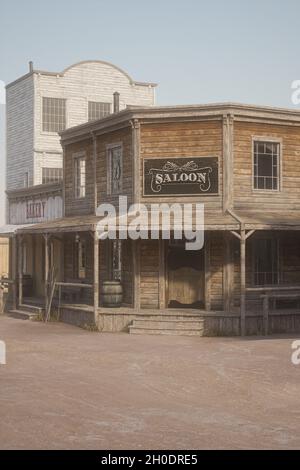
[167,240,205,309]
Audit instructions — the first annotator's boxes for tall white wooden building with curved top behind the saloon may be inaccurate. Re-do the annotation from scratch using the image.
[6,61,156,196]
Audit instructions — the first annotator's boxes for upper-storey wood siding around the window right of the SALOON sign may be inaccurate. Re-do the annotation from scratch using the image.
[233,121,300,212]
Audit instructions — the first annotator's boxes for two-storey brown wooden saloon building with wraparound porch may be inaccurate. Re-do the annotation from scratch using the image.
[7,104,300,335]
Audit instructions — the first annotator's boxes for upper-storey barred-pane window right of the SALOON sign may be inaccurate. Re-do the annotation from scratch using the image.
[254,141,280,190]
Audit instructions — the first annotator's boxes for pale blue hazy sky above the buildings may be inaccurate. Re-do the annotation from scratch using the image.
[0,0,300,223]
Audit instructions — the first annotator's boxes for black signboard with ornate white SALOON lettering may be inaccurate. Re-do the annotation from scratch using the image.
[144,157,219,196]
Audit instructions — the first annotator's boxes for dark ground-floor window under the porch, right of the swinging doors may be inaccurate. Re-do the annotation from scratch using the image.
[253,238,279,286]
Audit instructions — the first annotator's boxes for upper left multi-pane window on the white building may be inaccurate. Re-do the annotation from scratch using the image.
[42,98,66,132]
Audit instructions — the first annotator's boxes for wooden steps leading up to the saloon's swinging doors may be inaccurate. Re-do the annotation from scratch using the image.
[129,314,204,336]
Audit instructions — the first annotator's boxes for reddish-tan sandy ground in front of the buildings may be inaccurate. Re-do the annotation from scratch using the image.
[0,316,300,449]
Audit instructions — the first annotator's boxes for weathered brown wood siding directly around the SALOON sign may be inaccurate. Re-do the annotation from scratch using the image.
[140,120,223,210]
